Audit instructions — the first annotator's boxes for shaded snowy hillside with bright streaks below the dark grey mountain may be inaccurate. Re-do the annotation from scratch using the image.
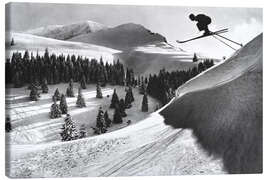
[115,42,205,75]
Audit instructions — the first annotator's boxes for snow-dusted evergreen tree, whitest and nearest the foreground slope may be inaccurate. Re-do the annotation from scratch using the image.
[60,114,79,141]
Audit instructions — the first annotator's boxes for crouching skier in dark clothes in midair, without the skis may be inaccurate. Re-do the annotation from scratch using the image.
[189,14,211,35]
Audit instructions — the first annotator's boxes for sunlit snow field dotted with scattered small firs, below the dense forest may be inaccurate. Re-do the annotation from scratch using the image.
[6,83,159,144]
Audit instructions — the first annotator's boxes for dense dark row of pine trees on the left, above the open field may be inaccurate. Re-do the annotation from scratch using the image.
[6,49,129,89]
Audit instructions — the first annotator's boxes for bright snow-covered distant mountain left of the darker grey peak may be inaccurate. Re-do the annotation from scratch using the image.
[25,21,107,40]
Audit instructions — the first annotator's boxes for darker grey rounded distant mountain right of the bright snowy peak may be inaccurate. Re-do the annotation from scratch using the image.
[69,23,167,50]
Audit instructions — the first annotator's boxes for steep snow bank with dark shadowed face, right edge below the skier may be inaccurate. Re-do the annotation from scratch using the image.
[161,34,263,173]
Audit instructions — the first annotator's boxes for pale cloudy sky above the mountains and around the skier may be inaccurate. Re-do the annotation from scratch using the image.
[6,3,263,58]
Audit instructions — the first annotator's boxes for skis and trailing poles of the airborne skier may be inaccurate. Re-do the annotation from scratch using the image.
[176,28,243,50]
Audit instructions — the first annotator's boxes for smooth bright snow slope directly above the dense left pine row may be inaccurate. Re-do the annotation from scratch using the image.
[6,33,120,62]
